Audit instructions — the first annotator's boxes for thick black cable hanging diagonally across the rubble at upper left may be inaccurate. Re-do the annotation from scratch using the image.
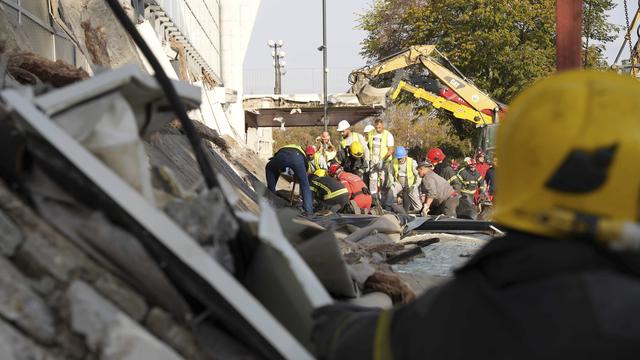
[102,0,218,189]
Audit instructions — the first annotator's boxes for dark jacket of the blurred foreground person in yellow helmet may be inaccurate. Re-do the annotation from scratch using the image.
[316,232,640,360]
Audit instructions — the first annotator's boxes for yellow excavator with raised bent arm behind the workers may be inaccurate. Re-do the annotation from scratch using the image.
[349,45,507,153]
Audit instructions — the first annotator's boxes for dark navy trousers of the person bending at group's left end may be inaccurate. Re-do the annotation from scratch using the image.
[265,151,313,214]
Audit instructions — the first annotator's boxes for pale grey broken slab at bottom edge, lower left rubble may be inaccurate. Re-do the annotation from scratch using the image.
[67,281,182,360]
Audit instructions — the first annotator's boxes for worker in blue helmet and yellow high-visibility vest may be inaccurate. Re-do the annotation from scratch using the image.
[389,146,422,212]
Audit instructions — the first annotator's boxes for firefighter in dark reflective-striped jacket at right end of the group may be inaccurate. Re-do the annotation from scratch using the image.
[452,158,485,219]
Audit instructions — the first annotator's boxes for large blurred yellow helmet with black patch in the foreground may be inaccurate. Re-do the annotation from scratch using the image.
[494,71,640,248]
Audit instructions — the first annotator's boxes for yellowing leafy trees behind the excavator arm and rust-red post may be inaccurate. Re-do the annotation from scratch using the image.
[359,0,616,138]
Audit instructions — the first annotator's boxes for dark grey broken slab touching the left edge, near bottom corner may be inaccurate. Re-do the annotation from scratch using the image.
[0,256,56,343]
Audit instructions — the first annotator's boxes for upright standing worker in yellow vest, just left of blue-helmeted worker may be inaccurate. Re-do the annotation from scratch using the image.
[367,118,394,200]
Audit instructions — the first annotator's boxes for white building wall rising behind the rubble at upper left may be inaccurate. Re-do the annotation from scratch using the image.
[0,0,271,156]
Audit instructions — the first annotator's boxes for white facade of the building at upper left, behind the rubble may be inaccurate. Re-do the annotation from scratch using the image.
[0,0,262,151]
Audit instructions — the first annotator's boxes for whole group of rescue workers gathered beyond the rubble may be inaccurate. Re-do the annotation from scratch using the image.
[266,118,495,219]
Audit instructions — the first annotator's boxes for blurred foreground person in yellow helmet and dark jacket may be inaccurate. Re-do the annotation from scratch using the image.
[313,72,640,360]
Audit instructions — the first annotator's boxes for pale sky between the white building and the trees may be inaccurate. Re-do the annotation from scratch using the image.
[244,0,638,94]
